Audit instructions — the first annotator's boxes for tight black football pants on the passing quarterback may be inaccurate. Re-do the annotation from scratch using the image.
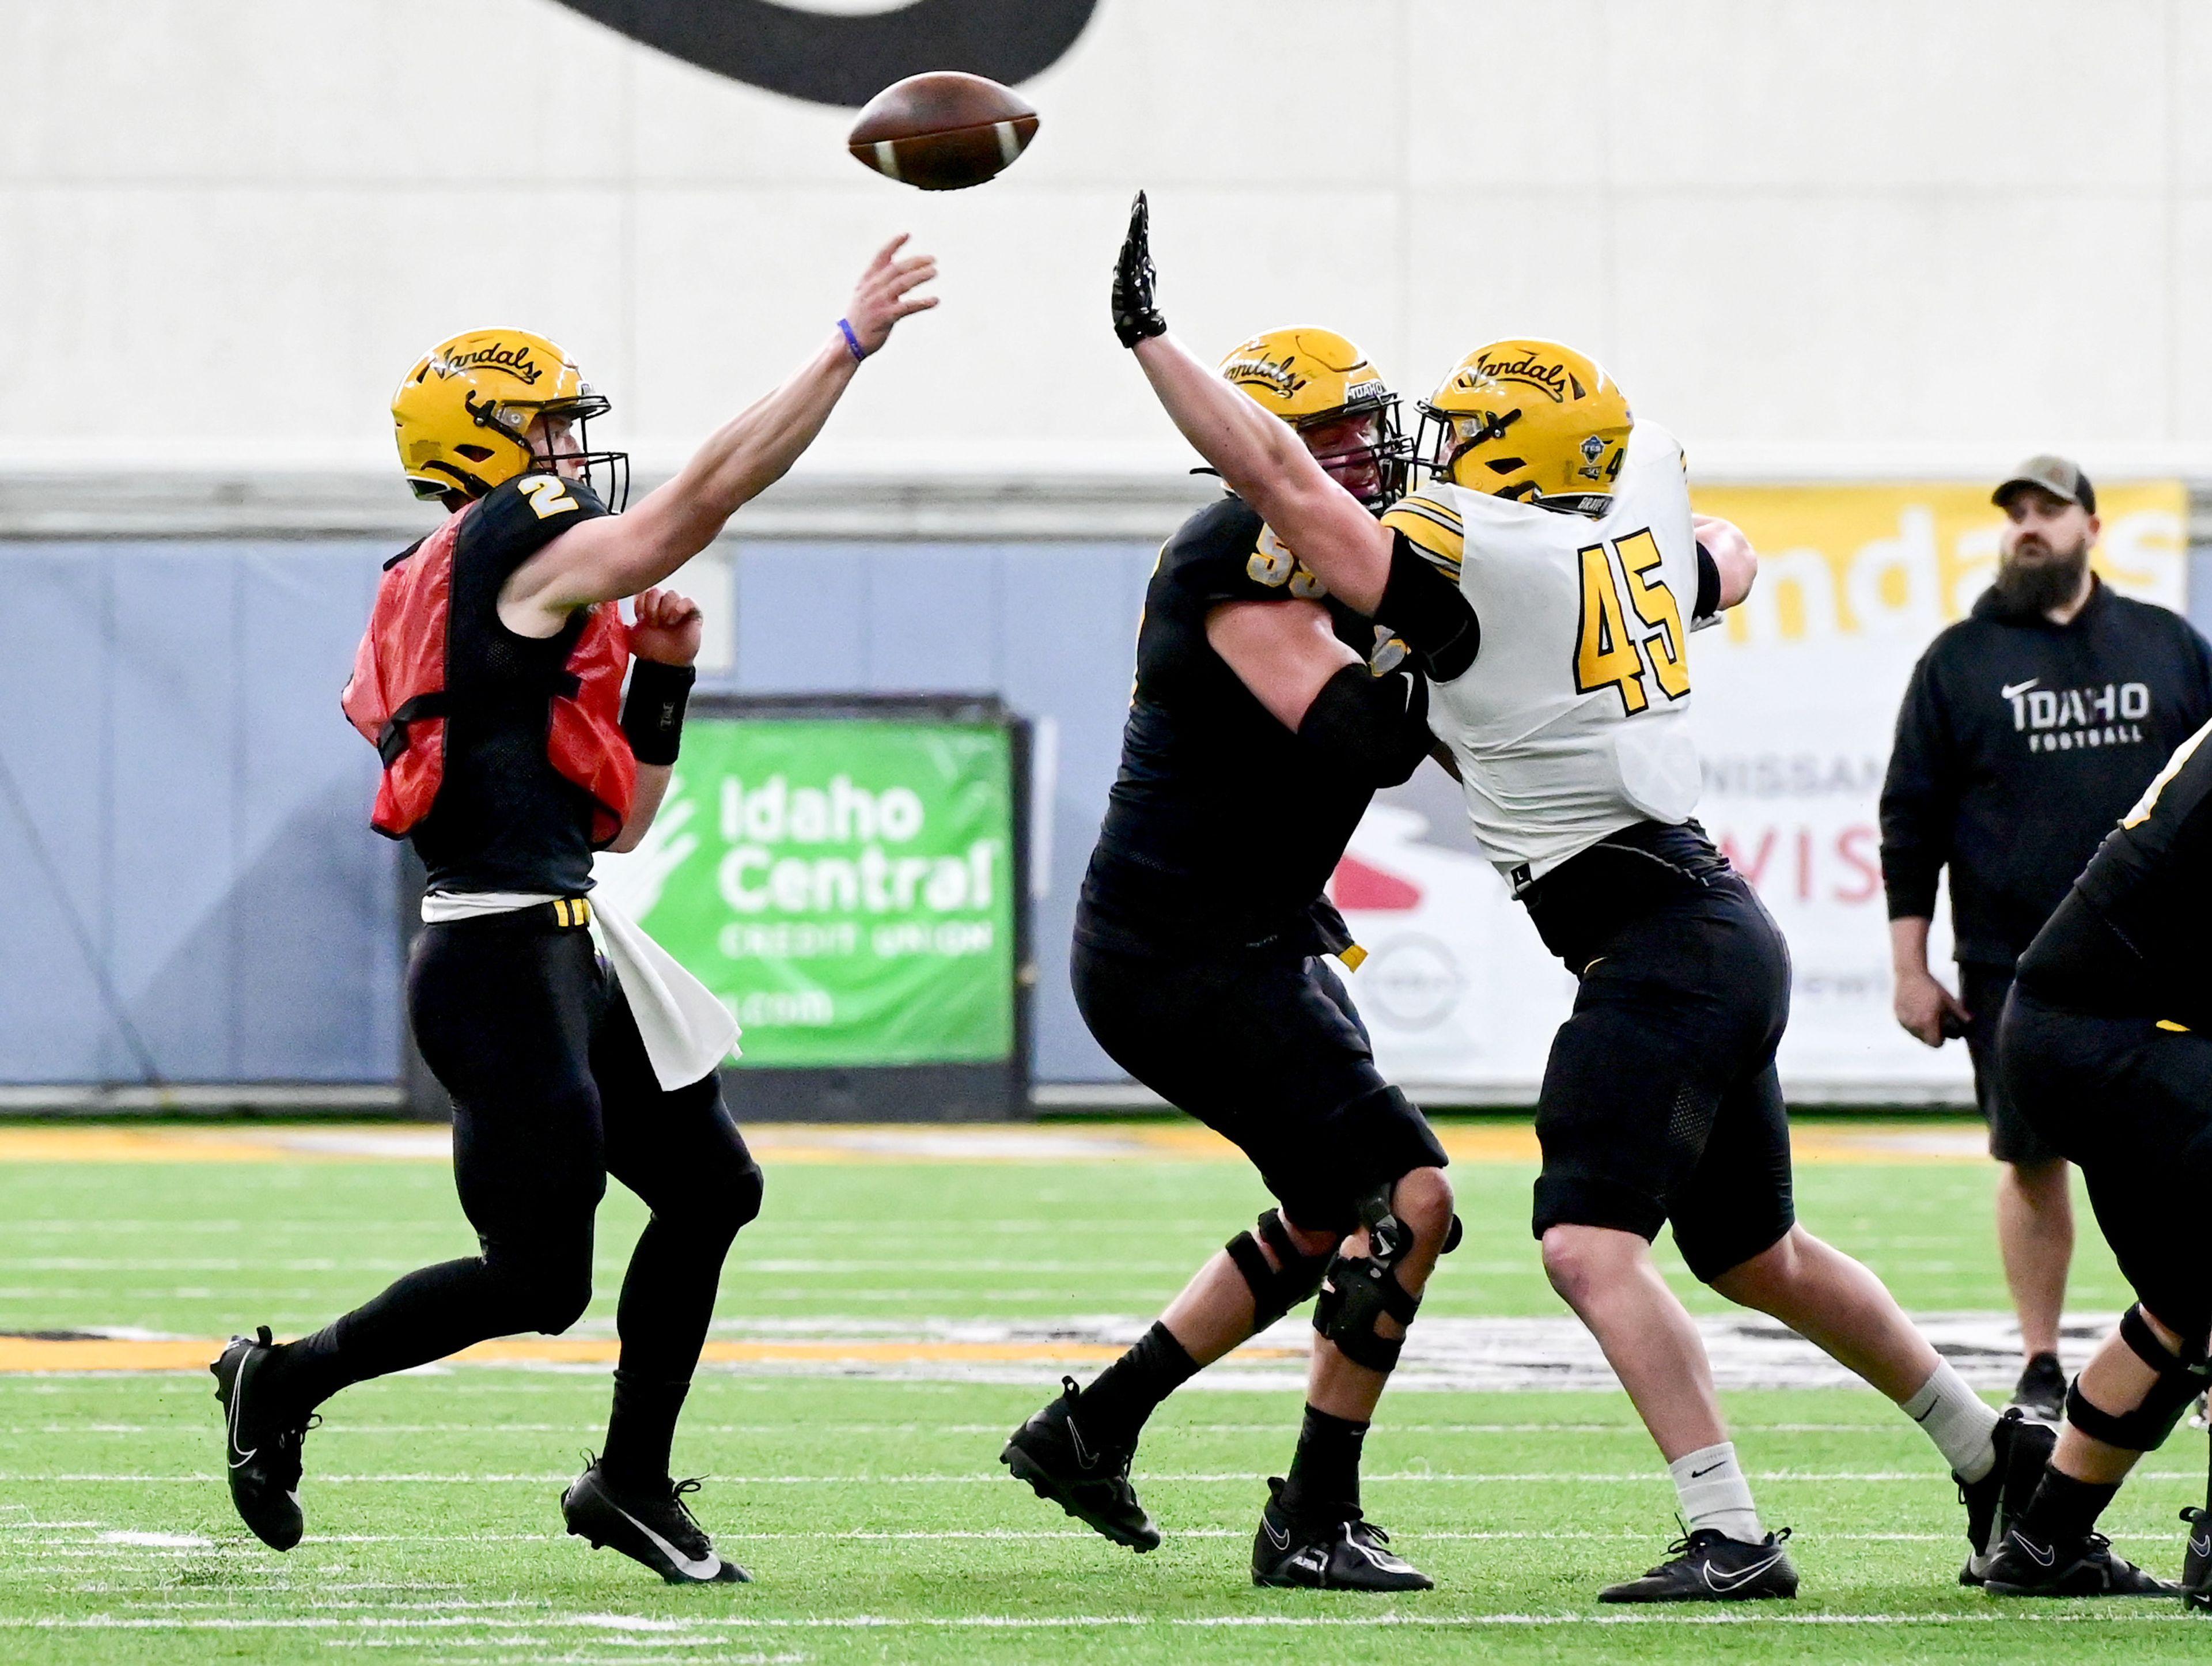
[266,905,761,1469]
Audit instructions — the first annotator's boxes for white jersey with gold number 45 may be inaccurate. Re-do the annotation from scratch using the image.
[1382,423,1701,892]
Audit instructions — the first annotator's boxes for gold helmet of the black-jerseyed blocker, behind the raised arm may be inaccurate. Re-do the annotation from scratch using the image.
[1221,330,1414,509]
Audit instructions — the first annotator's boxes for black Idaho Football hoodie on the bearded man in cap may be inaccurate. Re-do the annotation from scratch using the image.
[1883,582,2212,967]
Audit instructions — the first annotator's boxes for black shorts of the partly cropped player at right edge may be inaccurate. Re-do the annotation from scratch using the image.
[1998,987,2212,1343]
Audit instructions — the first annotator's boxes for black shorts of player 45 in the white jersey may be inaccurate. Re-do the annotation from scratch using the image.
[1535,874,1796,1283]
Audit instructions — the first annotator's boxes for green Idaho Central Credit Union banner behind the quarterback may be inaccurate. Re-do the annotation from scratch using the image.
[617,717,1016,1066]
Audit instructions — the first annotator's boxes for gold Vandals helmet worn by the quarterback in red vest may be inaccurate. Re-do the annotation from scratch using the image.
[392,330,630,511]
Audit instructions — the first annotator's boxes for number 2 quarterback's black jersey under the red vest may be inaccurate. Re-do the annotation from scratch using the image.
[411,474,606,896]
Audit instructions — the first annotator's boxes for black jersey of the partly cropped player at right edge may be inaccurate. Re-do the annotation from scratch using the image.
[2020,724,2212,1029]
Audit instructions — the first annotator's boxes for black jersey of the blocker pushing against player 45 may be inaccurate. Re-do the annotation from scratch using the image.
[1077,495,1403,953]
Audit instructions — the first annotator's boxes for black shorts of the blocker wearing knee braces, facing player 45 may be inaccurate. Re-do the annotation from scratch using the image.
[1071,938,1446,1232]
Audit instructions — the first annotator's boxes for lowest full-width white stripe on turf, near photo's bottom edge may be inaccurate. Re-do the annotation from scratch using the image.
[0,1608,2203,1640]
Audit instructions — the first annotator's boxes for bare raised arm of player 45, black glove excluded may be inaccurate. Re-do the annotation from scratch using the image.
[1132,336,1389,613]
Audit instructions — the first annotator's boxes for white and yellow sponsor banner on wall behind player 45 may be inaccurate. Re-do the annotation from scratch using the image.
[1334,482,2188,1102]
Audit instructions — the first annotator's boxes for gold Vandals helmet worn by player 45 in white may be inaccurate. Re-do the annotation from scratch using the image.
[1416,340,1637,518]
